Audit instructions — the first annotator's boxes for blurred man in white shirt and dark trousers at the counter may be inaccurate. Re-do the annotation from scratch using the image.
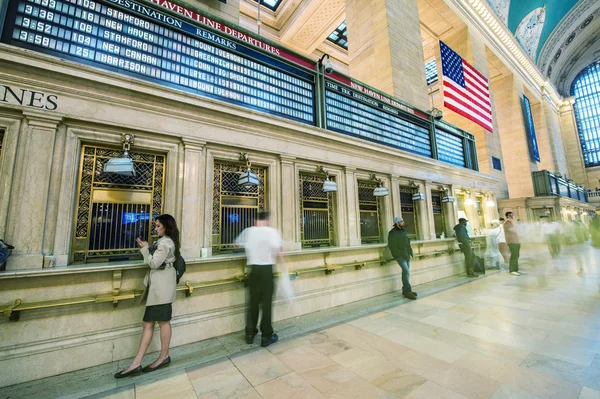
[236,212,283,346]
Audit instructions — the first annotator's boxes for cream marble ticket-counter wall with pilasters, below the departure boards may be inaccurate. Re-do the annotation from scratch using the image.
[0,41,499,386]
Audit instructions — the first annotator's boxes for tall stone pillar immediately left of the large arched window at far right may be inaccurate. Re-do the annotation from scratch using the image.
[560,98,595,187]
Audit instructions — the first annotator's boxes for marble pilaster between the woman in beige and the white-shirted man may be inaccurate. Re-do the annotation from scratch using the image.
[180,138,208,259]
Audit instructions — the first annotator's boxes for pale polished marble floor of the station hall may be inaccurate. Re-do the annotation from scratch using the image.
[0,244,600,399]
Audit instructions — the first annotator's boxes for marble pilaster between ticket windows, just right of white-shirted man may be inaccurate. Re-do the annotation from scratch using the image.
[279,155,302,251]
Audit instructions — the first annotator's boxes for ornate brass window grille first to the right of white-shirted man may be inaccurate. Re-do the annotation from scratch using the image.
[299,173,335,247]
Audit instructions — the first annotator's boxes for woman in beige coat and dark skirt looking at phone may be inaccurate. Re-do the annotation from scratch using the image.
[115,215,180,378]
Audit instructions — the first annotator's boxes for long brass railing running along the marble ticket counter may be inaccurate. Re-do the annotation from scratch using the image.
[0,248,459,321]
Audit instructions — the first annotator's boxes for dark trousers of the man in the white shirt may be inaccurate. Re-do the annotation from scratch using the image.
[246,265,275,339]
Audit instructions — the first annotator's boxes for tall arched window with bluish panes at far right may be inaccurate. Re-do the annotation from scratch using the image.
[571,62,600,167]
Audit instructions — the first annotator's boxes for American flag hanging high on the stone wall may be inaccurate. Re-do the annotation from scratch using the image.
[440,41,494,132]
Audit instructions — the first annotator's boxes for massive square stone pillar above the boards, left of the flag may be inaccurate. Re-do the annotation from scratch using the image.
[346,0,429,109]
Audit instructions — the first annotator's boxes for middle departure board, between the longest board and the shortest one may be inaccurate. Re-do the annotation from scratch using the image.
[325,81,432,158]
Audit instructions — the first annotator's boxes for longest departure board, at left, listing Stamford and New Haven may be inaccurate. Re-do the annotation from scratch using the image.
[2,0,315,124]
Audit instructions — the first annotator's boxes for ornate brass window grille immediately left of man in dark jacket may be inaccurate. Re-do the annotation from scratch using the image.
[358,181,381,244]
